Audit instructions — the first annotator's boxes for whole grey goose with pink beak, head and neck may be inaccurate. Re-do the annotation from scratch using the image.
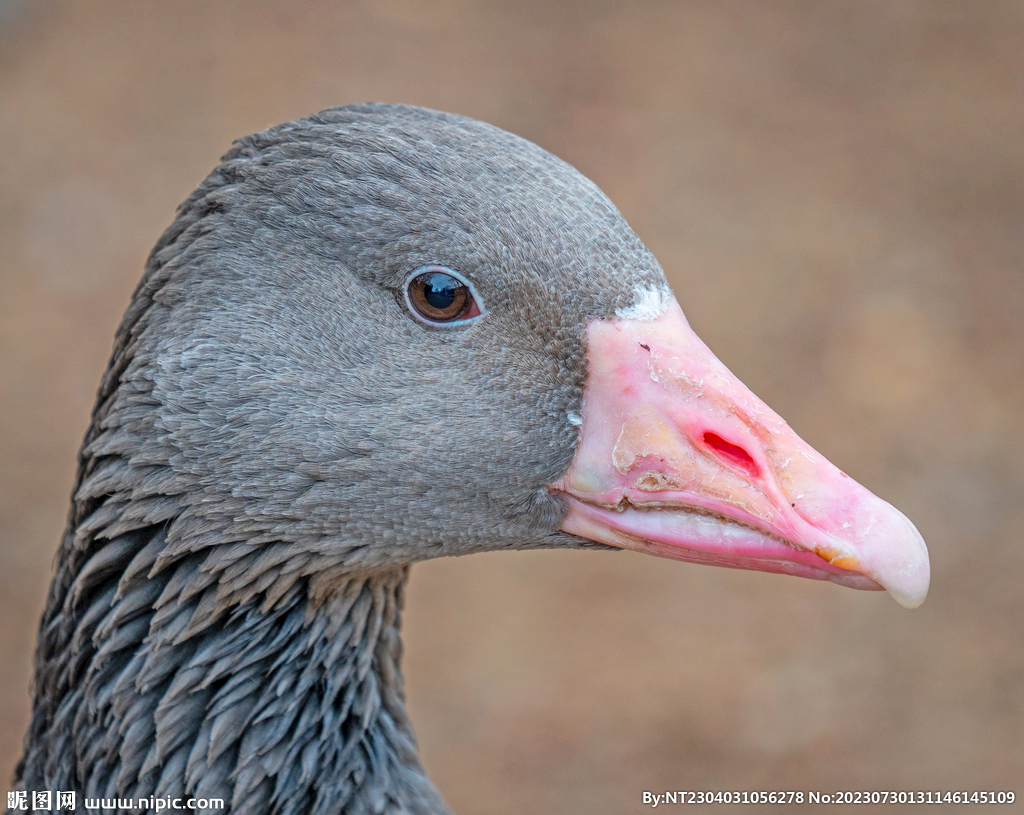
[15,104,929,815]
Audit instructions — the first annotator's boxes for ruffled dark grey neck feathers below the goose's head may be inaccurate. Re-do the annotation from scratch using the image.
[18,527,447,815]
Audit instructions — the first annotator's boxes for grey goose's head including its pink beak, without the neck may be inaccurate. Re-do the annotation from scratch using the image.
[140,105,929,606]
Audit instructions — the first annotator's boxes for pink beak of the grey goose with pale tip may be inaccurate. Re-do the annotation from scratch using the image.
[549,299,929,608]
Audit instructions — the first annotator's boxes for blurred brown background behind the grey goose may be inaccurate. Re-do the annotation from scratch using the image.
[0,0,1024,815]
